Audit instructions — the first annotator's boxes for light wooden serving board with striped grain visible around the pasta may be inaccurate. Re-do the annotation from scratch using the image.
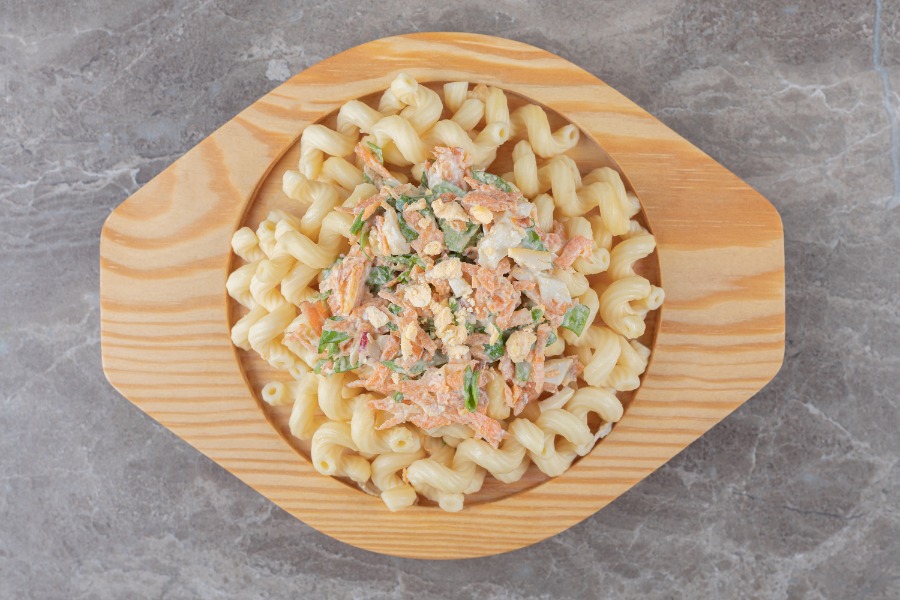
[100,33,784,558]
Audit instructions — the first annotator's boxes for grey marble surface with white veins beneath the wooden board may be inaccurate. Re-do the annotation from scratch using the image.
[0,0,900,600]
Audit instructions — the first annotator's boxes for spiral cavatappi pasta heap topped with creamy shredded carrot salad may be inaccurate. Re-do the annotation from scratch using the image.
[226,74,664,511]
